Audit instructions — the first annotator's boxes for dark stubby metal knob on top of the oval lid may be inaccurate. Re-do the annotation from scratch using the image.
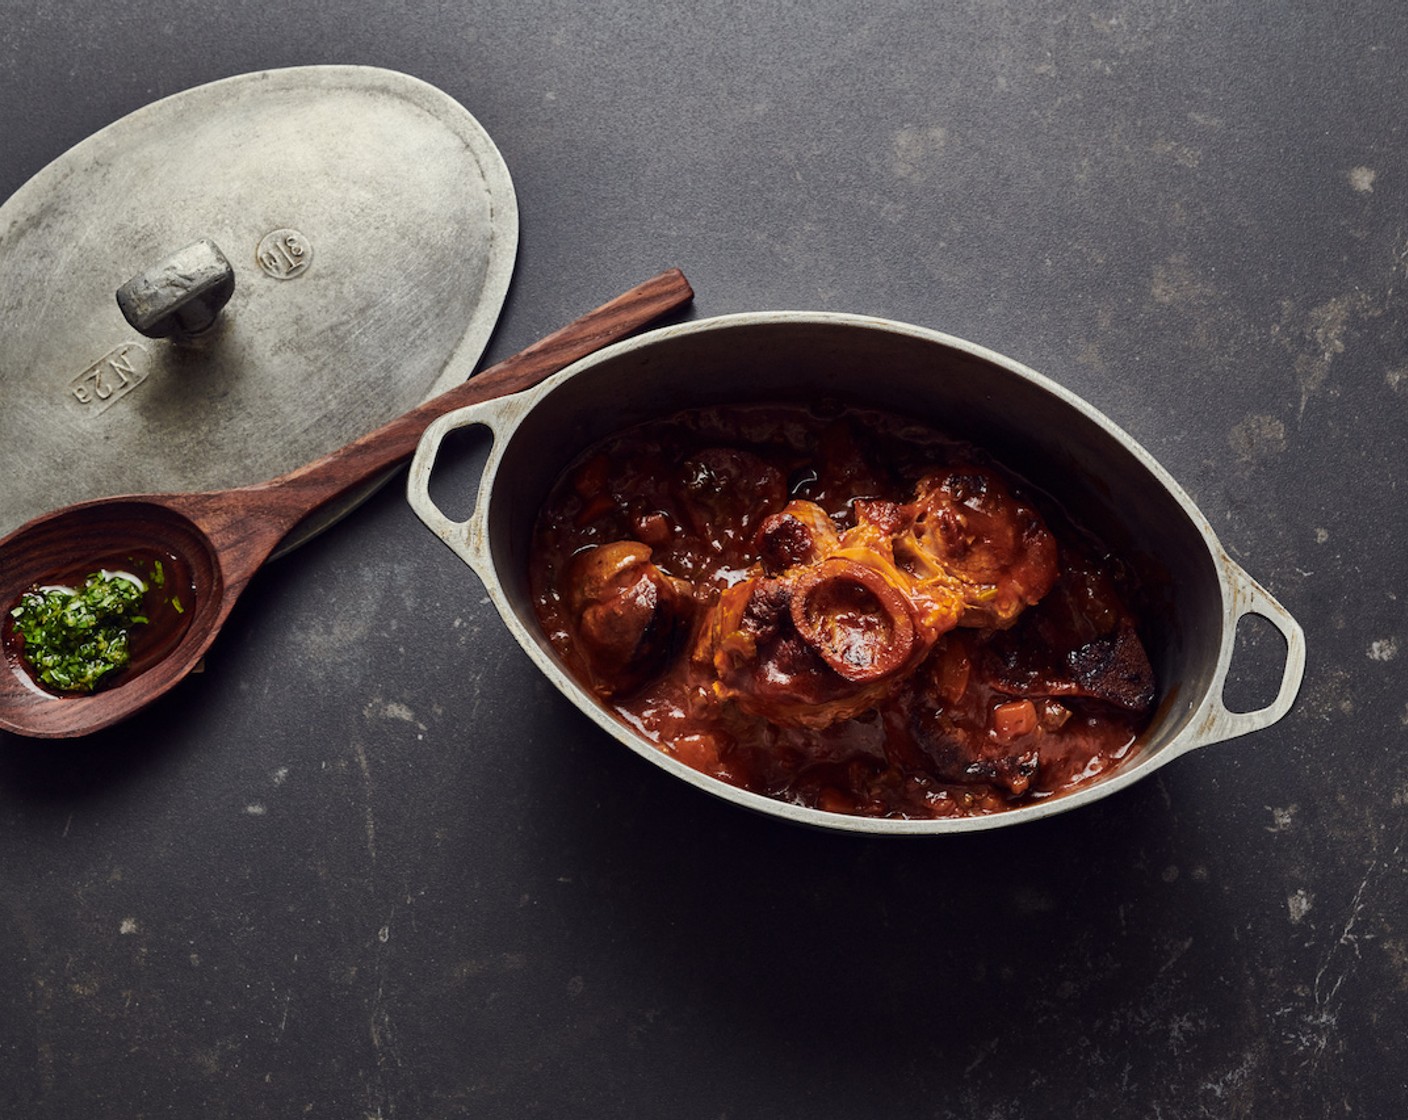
[117,239,235,338]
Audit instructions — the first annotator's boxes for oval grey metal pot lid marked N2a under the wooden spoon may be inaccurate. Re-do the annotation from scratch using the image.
[0,66,518,547]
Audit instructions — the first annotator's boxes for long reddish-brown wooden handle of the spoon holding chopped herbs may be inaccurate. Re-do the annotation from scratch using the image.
[233,269,694,538]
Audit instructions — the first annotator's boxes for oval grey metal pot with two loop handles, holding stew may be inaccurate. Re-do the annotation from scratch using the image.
[408,311,1305,834]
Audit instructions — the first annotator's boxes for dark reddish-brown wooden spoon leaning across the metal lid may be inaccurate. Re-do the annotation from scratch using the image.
[0,269,694,738]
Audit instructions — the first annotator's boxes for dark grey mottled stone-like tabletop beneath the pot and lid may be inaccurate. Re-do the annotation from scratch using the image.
[0,0,1408,1120]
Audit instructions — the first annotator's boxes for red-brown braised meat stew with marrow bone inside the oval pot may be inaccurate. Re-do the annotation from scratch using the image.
[529,406,1157,817]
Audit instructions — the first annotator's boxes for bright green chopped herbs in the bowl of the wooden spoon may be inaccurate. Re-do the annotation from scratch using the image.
[10,569,146,692]
